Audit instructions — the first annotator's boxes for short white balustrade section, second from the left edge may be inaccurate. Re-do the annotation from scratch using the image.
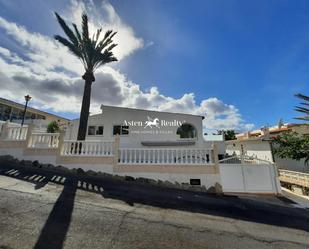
[28,133,60,148]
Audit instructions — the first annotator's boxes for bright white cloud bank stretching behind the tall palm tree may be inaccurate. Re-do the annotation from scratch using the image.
[0,1,253,130]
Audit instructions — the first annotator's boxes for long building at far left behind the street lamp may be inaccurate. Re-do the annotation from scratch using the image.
[0,98,69,124]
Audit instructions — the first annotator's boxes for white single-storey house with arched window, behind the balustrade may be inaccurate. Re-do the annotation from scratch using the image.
[65,105,225,154]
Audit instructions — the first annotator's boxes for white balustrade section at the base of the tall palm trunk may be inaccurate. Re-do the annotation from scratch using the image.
[61,140,114,156]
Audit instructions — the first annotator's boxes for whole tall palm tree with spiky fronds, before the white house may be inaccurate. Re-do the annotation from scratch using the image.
[54,12,117,140]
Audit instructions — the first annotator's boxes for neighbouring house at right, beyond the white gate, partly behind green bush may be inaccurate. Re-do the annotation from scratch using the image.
[226,124,309,172]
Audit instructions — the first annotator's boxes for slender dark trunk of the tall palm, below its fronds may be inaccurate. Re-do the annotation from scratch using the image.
[77,72,95,140]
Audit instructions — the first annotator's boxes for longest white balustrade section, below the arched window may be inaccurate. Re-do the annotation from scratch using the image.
[118,148,213,165]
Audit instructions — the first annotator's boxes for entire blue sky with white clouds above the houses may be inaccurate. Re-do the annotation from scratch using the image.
[0,0,309,130]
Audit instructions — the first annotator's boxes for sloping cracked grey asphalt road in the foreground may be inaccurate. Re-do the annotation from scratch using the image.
[0,165,309,249]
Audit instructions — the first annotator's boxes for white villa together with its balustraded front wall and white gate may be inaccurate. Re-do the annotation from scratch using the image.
[0,102,281,194]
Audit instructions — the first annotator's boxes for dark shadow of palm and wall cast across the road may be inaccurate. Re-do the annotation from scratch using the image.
[0,161,309,235]
